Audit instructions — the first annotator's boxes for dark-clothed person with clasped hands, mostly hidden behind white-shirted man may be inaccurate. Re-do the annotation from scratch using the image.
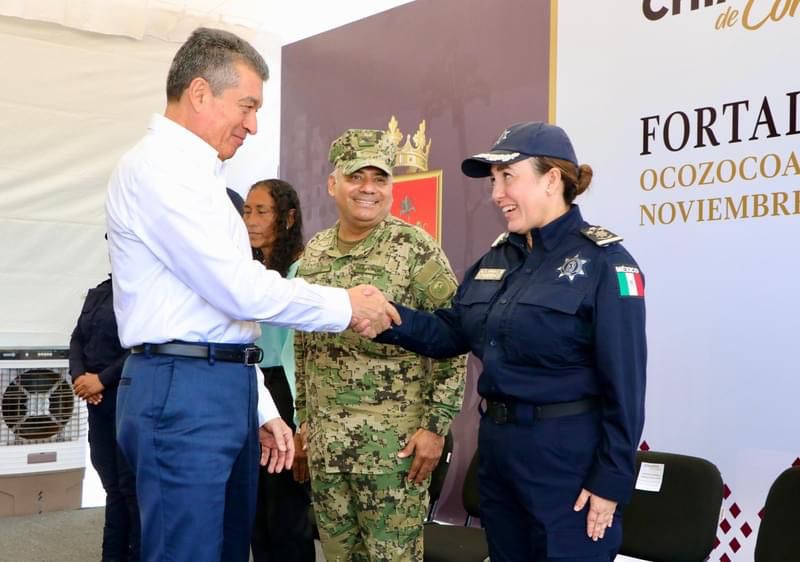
[69,276,139,562]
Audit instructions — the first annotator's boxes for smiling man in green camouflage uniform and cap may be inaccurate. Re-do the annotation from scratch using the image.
[295,129,465,562]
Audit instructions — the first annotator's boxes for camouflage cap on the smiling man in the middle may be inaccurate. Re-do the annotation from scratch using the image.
[328,129,397,175]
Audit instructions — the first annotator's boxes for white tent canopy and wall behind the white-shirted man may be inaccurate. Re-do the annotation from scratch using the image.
[0,0,412,347]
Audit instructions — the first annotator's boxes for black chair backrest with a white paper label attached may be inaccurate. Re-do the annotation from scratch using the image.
[620,451,723,562]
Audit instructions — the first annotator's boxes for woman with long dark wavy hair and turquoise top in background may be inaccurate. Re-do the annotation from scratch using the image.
[243,179,315,562]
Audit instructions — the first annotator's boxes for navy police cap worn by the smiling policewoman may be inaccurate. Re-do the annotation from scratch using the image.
[461,121,578,178]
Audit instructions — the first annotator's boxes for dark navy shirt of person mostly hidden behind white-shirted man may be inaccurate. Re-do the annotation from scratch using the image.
[69,277,128,390]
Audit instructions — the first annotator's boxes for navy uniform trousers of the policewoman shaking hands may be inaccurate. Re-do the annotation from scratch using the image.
[478,412,622,562]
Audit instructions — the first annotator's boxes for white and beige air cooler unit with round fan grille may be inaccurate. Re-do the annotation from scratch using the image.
[0,348,87,517]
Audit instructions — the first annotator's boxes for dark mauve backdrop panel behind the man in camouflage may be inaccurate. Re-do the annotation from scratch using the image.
[280,0,551,523]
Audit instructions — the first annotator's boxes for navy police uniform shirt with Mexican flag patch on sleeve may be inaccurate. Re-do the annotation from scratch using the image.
[377,205,647,502]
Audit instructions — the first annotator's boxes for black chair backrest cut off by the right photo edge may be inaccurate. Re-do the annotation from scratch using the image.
[755,466,800,562]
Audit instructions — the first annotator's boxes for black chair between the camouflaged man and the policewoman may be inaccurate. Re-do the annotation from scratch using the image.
[423,450,489,562]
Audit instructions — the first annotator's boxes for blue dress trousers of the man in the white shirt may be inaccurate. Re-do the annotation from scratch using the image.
[117,354,259,562]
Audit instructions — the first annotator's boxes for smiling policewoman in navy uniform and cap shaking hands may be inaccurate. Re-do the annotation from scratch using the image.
[378,123,647,562]
